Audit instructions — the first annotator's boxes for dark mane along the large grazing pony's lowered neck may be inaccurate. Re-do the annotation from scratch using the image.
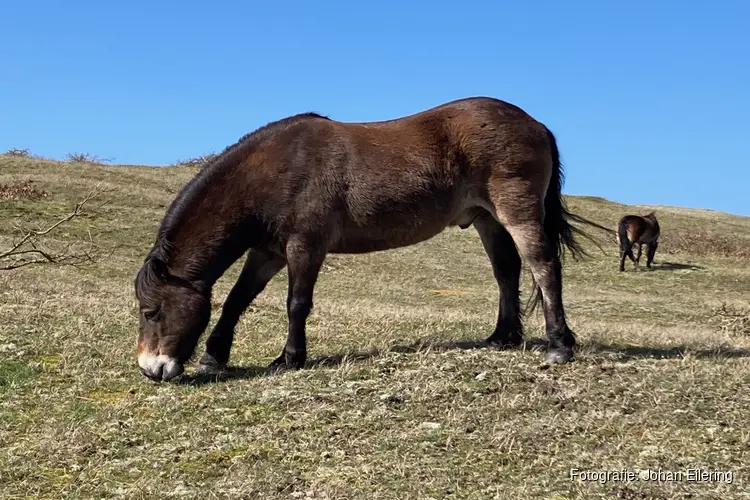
[152,113,330,262]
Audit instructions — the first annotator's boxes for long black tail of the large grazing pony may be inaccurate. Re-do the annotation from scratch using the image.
[526,127,596,312]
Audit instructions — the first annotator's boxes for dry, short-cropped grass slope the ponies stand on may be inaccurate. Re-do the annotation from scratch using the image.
[0,156,750,499]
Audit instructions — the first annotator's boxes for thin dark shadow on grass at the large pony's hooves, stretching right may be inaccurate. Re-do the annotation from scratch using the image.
[178,338,750,386]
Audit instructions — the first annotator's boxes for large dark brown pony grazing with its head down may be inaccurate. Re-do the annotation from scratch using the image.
[135,97,588,380]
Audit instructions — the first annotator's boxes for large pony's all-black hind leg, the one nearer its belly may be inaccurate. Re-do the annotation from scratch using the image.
[474,212,523,347]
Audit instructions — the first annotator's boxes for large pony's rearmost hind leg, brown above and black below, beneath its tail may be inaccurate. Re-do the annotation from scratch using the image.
[495,198,576,363]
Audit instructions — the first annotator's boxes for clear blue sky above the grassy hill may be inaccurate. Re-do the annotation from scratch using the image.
[0,0,750,215]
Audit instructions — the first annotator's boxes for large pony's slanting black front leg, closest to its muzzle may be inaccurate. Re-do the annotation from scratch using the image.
[197,250,286,373]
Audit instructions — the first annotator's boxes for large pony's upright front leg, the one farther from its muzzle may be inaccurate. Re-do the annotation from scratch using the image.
[271,238,326,369]
